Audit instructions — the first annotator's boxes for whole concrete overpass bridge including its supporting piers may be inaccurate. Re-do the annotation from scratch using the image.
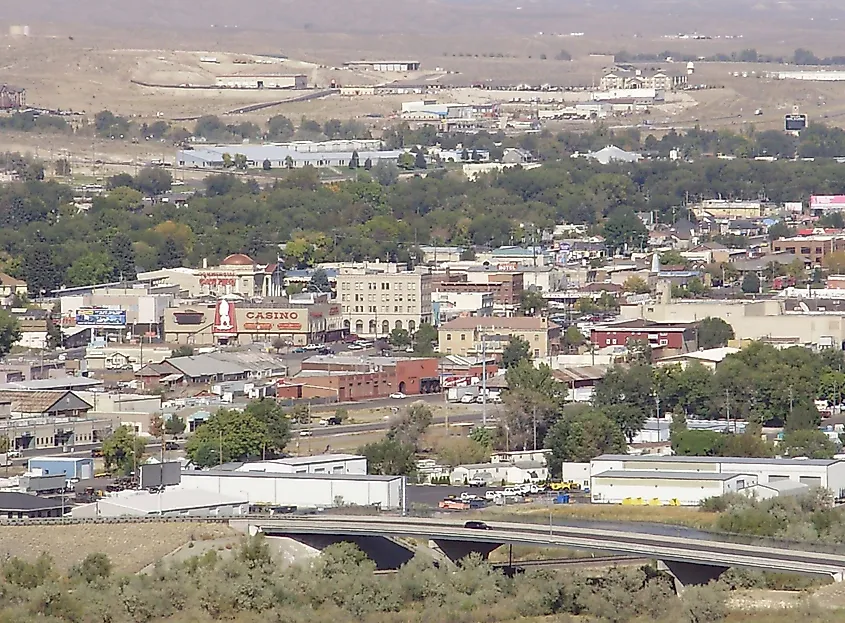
[246,515,845,586]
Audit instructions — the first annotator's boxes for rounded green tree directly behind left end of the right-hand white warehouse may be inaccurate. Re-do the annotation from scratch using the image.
[544,407,627,470]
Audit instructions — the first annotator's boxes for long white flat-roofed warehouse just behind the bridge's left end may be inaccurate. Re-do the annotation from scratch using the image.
[181,469,405,510]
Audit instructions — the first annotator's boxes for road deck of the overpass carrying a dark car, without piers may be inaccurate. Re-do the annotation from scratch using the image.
[249,516,845,581]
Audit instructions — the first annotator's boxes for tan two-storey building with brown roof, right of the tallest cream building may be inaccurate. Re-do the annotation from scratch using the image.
[437,317,560,359]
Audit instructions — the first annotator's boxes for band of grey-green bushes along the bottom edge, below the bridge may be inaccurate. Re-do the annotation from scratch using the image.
[0,535,728,623]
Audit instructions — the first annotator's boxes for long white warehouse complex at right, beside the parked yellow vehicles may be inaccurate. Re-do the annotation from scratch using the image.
[590,454,845,503]
